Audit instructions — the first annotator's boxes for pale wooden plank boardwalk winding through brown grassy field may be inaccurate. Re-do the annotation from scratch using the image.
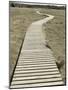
[10,10,63,88]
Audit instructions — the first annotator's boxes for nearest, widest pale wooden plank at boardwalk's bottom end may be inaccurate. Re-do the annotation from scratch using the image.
[10,81,63,88]
